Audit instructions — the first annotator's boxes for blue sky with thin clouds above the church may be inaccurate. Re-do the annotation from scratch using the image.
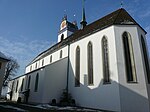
[0,0,150,75]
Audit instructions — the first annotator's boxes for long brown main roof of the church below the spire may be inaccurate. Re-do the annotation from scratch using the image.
[30,8,146,64]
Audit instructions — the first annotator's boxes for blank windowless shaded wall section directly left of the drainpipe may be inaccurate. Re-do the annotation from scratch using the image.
[42,58,68,103]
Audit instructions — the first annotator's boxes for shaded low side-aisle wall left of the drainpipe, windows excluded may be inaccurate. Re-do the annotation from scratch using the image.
[9,57,68,103]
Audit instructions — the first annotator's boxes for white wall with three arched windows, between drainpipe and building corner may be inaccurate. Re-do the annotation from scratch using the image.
[69,26,120,111]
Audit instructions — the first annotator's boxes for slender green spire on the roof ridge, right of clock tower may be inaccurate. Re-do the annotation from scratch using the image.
[80,0,87,29]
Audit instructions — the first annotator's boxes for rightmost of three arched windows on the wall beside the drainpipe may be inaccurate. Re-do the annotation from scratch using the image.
[101,36,110,83]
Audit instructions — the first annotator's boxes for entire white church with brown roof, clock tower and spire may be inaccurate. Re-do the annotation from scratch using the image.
[9,8,150,112]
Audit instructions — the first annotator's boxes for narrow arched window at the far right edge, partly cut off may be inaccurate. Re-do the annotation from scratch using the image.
[141,35,150,83]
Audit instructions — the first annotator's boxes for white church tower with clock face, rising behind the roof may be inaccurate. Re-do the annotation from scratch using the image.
[58,15,78,42]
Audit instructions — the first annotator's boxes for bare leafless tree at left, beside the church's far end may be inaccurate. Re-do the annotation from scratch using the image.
[3,57,20,87]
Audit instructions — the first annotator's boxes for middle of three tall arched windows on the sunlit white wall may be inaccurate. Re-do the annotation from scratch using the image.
[87,42,93,85]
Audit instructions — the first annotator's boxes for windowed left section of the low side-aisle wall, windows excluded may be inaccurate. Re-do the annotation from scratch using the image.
[9,68,45,103]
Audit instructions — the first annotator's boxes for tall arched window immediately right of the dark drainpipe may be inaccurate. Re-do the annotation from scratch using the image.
[75,46,80,87]
